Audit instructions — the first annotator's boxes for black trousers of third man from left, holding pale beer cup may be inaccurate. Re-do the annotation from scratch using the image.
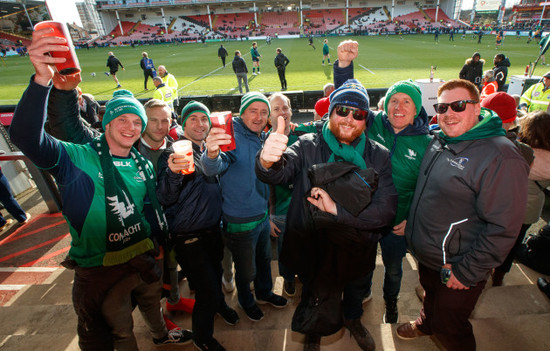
[175,226,226,344]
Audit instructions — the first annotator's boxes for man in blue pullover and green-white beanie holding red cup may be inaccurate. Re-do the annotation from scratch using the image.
[201,92,288,322]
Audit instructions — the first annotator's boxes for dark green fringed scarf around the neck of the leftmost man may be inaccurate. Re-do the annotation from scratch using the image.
[93,134,168,266]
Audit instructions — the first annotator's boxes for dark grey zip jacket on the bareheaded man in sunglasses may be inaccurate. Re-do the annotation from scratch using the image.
[405,136,529,286]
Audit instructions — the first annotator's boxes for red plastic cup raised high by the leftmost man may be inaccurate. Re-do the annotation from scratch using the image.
[34,21,80,76]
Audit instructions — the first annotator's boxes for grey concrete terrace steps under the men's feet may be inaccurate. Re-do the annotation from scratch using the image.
[0,250,550,351]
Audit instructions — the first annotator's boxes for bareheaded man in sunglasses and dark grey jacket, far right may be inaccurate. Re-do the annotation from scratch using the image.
[396,79,529,351]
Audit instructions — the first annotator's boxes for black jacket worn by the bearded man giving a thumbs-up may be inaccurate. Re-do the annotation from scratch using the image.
[256,125,397,291]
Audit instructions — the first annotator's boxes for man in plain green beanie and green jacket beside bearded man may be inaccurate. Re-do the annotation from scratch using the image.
[334,40,431,323]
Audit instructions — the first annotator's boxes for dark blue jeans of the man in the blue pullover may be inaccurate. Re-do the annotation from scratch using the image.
[224,218,273,308]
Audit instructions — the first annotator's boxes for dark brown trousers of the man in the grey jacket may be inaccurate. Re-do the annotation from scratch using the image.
[415,264,487,351]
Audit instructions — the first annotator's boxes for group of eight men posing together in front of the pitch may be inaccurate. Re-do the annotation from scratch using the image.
[10,29,528,350]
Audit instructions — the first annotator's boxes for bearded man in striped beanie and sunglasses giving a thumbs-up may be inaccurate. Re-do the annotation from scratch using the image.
[256,79,397,350]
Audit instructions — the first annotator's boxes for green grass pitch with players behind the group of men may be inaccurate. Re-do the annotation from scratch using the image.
[0,35,550,105]
